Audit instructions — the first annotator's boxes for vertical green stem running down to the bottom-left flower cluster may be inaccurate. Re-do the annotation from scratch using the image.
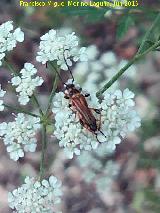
[39,124,47,181]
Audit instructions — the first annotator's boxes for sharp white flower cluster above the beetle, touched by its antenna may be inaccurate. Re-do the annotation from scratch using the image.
[36,29,87,70]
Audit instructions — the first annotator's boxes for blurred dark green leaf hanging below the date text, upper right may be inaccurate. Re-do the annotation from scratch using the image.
[117,15,134,39]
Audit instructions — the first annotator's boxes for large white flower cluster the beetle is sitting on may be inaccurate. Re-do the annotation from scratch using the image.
[52,83,140,158]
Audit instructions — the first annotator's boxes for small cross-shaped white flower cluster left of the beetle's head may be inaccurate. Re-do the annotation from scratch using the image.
[11,63,43,105]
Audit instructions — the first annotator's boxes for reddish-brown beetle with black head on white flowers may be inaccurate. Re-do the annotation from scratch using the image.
[64,83,106,142]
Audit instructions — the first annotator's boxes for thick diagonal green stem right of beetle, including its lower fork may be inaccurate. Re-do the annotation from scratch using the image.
[96,41,160,97]
